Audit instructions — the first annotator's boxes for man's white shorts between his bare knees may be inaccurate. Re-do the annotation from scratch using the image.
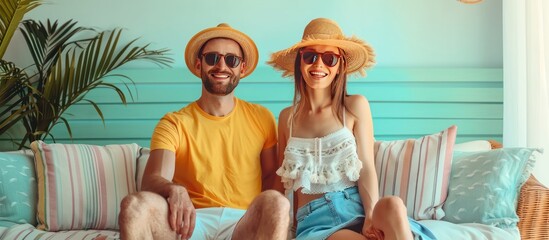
[191,207,246,240]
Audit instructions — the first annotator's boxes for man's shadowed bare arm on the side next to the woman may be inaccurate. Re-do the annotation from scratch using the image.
[260,144,284,193]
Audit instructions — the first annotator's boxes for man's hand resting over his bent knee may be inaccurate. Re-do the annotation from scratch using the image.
[167,184,196,239]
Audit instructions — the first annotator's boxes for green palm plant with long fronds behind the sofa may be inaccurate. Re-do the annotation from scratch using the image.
[0,0,172,148]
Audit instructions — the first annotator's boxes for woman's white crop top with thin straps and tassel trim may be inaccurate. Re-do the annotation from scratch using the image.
[276,111,362,194]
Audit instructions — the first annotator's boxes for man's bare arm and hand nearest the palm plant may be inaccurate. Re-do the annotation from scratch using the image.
[141,149,196,239]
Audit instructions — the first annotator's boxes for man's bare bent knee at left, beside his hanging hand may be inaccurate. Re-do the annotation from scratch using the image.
[118,192,177,240]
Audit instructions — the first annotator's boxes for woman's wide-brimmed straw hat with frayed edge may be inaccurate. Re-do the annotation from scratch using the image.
[267,18,375,77]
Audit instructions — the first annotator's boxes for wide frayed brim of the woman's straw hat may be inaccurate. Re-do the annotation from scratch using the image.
[267,37,375,77]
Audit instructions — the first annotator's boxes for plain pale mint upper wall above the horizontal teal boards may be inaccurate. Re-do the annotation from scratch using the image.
[4,0,503,67]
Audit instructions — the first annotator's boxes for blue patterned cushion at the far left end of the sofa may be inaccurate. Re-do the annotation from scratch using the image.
[0,151,36,227]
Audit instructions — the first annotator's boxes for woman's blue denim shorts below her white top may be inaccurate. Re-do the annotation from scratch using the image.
[296,186,436,240]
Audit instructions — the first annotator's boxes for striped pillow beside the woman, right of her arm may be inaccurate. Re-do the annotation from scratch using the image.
[374,126,457,220]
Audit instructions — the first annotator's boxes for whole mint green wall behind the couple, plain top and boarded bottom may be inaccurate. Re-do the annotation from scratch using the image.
[0,0,503,150]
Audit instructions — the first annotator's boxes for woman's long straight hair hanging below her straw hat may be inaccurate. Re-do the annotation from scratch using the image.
[289,49,349,124]
